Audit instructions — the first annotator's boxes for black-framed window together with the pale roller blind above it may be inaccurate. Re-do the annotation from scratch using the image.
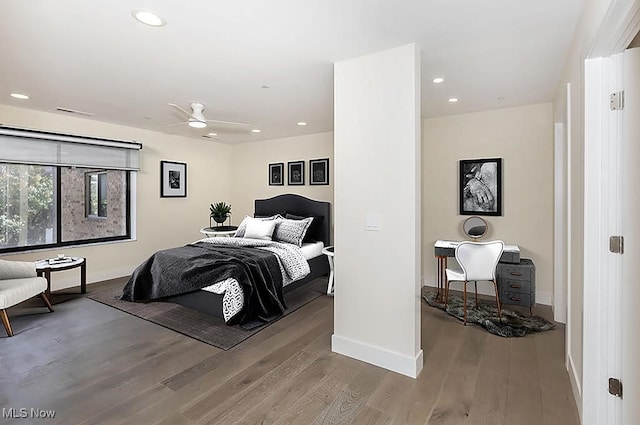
[0,126,142,254]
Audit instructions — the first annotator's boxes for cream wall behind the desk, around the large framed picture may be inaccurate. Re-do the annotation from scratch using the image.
[422,104,553,304]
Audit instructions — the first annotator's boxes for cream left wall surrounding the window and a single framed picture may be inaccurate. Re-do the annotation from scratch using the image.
[0,105,232,290]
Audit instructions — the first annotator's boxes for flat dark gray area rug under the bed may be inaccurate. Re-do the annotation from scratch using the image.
[87,278,327,350]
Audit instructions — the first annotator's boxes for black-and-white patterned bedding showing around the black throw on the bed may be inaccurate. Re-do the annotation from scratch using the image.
[198,237,312,322]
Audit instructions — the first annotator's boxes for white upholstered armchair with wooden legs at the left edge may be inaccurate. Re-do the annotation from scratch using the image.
[0,260,53,336]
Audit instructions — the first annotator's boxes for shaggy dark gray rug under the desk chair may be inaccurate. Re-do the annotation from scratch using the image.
[422,289,555,337]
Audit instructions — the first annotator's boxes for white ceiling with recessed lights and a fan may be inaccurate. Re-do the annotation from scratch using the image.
[0,0,584,143]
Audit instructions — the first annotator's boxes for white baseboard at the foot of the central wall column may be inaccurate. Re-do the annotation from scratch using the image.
[331,334,423,378]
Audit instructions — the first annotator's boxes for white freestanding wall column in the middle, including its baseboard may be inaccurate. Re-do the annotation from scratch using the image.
[332,45,422,377]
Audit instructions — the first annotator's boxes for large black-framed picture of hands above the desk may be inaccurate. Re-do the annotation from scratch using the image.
[459,158,502,216]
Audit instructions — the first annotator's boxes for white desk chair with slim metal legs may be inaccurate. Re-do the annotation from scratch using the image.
[444,241,504,325]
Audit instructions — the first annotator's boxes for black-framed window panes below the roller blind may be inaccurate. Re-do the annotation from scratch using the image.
[0,163,130,252]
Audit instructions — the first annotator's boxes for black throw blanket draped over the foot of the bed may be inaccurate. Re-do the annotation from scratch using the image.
[120,242,286,327]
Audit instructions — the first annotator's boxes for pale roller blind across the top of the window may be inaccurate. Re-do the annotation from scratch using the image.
[0,126,142,171]
